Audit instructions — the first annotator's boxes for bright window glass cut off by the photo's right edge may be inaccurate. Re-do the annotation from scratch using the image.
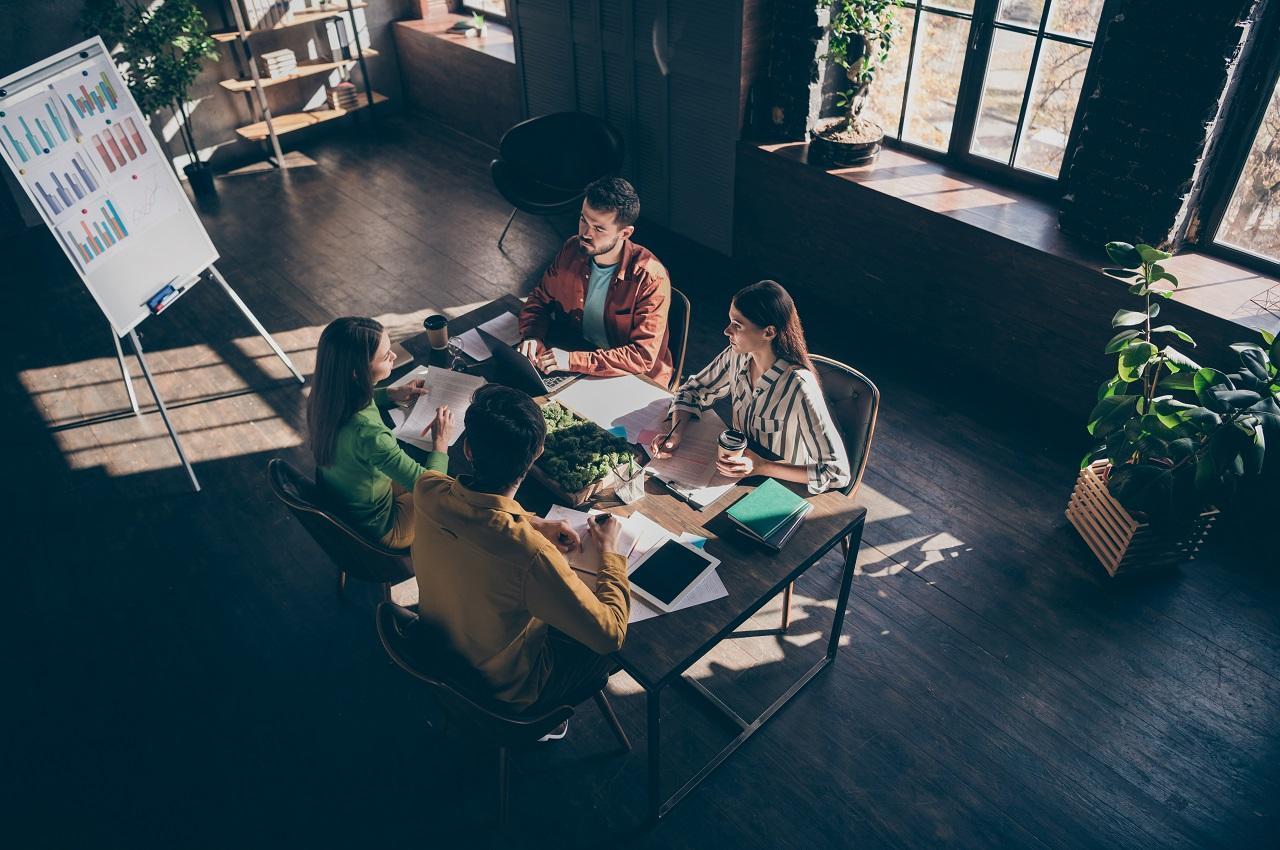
[1215,75,1280,262]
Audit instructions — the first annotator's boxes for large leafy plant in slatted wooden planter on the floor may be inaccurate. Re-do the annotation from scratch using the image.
[1066,242,1280,575]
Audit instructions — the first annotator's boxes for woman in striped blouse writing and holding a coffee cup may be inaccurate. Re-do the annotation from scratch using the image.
[649,280,850,493]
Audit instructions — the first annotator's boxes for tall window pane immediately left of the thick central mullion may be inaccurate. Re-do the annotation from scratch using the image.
[902,12,969,151]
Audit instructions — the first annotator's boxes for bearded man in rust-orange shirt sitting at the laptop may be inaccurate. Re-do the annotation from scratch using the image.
[520,177,673,387]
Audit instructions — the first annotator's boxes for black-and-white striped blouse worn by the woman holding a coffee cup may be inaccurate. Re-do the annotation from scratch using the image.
[672,348,850,493]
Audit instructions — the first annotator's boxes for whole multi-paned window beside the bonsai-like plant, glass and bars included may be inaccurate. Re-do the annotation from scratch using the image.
[864,0,1103,182]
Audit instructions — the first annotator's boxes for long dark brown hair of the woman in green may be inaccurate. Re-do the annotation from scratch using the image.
[307,316,383,466]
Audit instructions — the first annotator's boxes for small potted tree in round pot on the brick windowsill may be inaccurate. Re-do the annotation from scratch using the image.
[809,0,902,165]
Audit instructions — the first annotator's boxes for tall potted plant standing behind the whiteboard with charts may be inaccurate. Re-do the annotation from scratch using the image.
[81,0,216,197]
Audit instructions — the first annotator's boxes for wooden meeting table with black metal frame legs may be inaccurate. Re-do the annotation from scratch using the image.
[397,294,867,822]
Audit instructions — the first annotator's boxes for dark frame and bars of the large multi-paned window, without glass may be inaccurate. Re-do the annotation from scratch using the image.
[872,0,1119,196]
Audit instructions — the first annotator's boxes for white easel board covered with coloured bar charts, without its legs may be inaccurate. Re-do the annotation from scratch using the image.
[0,36,218,337]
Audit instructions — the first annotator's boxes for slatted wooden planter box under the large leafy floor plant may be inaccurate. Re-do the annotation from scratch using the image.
[1066,461,1217,576]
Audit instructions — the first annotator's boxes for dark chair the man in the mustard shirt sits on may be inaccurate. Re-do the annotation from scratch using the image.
[376,602,631,823]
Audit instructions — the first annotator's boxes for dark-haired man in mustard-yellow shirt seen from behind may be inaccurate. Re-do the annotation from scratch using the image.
[412,384,630,709]
